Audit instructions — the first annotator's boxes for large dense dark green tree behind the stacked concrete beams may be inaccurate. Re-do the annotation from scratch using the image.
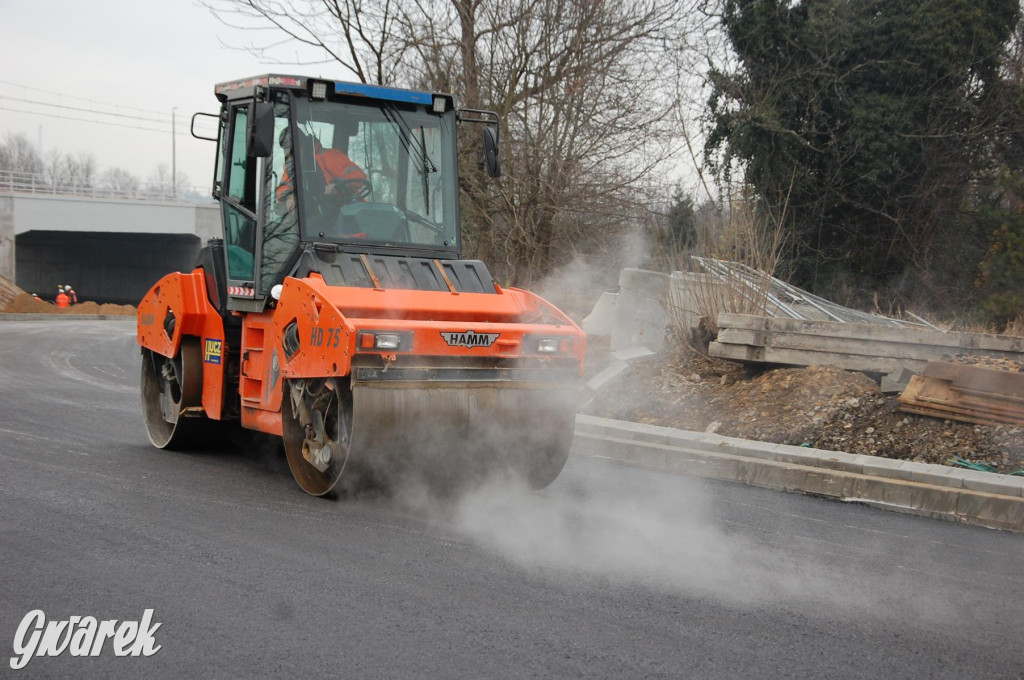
[707,0,1020,303]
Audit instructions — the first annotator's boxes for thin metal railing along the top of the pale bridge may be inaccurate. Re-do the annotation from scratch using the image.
[0,170,213,203]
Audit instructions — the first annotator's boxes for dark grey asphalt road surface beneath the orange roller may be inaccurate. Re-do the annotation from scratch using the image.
[0,321,1024,678]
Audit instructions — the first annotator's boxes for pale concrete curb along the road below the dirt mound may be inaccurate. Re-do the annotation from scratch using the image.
[572,415,1024,533]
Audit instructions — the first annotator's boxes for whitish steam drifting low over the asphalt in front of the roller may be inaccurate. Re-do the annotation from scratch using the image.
[387,460,955,621]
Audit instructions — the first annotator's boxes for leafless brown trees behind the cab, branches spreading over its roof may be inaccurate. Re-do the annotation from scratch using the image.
[204,0,686,283]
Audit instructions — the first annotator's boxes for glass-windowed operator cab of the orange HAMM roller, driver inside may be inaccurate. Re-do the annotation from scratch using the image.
[194,76,499,310]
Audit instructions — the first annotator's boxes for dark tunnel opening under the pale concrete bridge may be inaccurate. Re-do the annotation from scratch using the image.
[14,230,202,304]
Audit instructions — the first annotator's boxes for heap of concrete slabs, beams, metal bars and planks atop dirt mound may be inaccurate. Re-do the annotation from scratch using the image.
[585,257,1024,425]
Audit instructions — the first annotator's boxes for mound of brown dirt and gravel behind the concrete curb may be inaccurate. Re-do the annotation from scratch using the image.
[584,338,1024,472]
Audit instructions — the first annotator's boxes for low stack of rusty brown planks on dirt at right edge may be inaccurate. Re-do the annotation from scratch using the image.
[899,356,1024,426]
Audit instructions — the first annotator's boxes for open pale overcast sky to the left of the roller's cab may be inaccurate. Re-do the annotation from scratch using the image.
[0,0,350,191]
